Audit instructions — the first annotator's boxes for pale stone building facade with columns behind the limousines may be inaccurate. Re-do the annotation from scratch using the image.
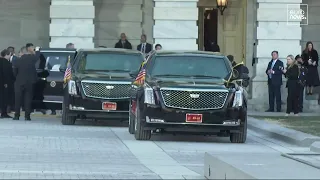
[0,0,320,109]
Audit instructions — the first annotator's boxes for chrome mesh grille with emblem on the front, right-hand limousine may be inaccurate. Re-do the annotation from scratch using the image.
[160,89,228,110]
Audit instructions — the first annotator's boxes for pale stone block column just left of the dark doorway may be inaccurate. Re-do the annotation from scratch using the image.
[153,0,198,50]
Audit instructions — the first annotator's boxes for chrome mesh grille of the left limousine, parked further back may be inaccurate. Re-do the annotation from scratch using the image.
[81,81,131,99]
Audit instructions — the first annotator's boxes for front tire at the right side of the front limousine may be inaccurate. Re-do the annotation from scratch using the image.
[230,108,248,143]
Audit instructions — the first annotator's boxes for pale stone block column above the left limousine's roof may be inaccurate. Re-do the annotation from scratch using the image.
[50,0,95,48]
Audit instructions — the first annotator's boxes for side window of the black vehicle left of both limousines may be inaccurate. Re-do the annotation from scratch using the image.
[39,52,74,71]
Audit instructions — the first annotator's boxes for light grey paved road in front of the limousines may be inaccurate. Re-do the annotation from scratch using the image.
[0,117,318,179]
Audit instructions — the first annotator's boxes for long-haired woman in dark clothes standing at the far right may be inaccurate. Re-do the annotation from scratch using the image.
[302,41,320,95]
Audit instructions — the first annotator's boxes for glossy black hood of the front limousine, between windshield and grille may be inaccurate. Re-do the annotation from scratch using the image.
[146,78,226,89]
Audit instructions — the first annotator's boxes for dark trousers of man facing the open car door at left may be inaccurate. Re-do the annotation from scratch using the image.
[14,84,33,117]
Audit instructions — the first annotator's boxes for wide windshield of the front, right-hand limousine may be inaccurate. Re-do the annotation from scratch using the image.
[150,56,231,78]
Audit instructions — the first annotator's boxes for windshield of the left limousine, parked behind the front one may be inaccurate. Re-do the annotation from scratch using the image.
[78,53,143,72]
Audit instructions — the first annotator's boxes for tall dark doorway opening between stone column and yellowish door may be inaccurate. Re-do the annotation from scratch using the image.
[203,8,220,52]
